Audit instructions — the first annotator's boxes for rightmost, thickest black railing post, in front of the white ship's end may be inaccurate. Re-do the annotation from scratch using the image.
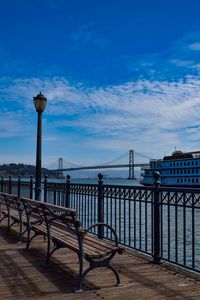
[153,171,160,264]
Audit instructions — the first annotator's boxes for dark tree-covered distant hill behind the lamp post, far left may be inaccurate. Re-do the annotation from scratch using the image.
[0,163,57,178]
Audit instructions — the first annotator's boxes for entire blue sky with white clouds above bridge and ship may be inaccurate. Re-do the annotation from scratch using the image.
[0,0,200,168]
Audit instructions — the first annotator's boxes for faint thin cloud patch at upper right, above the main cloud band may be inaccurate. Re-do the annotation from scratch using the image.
[122,32,200,81]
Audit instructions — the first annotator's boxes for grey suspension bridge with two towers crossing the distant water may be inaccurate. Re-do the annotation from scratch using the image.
[49,149,150,179]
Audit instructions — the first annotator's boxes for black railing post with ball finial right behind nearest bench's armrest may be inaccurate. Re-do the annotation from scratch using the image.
[98,173,104,238]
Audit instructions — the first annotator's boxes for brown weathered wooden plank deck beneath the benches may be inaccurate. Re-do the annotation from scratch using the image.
[0,224,200,300]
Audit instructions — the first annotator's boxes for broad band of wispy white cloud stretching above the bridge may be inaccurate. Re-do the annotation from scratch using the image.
[0,76,200,159]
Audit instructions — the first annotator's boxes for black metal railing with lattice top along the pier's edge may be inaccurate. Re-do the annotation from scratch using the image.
[0,174,200,272]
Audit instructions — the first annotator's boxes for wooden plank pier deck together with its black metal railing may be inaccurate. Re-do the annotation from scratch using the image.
[0,174,200,300]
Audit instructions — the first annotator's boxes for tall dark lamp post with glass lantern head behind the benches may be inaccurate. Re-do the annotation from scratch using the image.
[33,92,47,200]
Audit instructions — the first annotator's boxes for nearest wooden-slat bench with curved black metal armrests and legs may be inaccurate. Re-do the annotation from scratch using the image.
[21,198,123,292]
